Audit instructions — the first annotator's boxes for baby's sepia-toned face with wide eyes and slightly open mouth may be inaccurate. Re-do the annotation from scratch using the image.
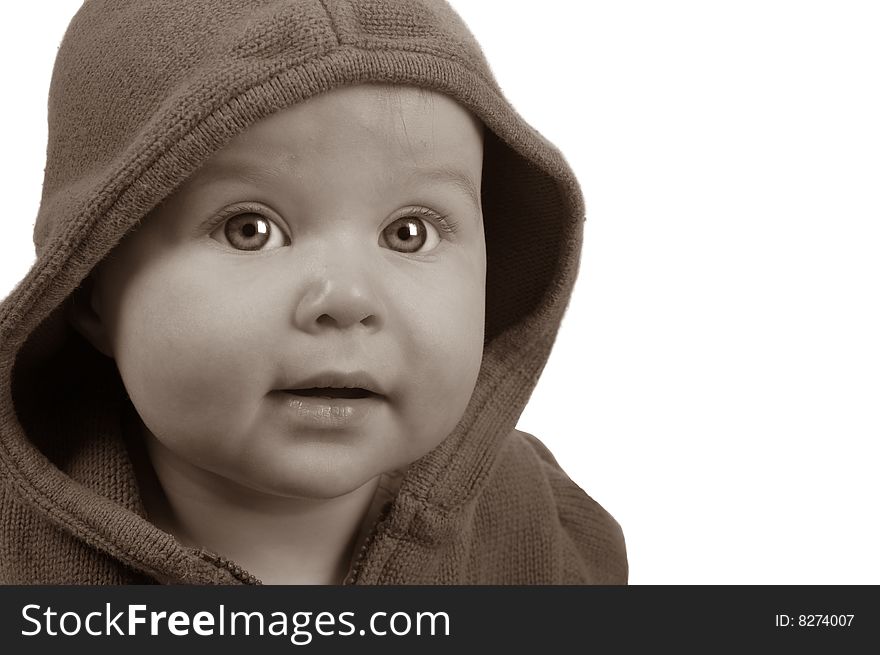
[93,86,486,498]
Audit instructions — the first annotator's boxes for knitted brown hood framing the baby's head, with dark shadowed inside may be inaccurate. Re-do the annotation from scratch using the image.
[0,0,584,582]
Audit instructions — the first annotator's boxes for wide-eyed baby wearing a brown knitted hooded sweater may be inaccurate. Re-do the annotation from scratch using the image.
[0,0,627,584]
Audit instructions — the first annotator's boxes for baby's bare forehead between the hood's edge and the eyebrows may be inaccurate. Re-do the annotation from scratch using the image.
[191,85,483,196]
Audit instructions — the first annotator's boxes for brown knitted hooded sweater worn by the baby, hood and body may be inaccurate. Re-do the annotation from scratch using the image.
[0,0,627,584]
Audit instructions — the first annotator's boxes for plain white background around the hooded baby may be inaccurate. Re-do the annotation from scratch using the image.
[0,0,880,584]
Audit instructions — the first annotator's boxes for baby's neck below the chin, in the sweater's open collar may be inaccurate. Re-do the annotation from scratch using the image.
[130,435,379,584]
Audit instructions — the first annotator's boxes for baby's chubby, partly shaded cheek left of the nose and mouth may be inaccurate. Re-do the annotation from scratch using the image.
[116,274,266,448]
